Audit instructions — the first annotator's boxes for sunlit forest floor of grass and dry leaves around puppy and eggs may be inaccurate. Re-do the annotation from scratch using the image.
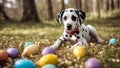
[0,19,120,68]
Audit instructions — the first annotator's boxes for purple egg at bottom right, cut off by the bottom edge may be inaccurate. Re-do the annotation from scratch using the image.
[86,58,101,68]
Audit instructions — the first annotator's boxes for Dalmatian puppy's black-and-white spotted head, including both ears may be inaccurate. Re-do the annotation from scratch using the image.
[56,8,86,30]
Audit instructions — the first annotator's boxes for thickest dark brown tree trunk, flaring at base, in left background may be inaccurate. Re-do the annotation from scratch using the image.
[21,0,41,22]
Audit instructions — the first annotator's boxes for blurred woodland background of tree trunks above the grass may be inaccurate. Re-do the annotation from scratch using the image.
[0,0,120,21]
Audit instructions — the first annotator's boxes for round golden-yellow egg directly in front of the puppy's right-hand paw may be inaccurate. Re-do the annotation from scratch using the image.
[73,45,86,58]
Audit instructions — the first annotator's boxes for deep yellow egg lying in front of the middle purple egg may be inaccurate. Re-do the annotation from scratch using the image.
[38,54,58,67]
